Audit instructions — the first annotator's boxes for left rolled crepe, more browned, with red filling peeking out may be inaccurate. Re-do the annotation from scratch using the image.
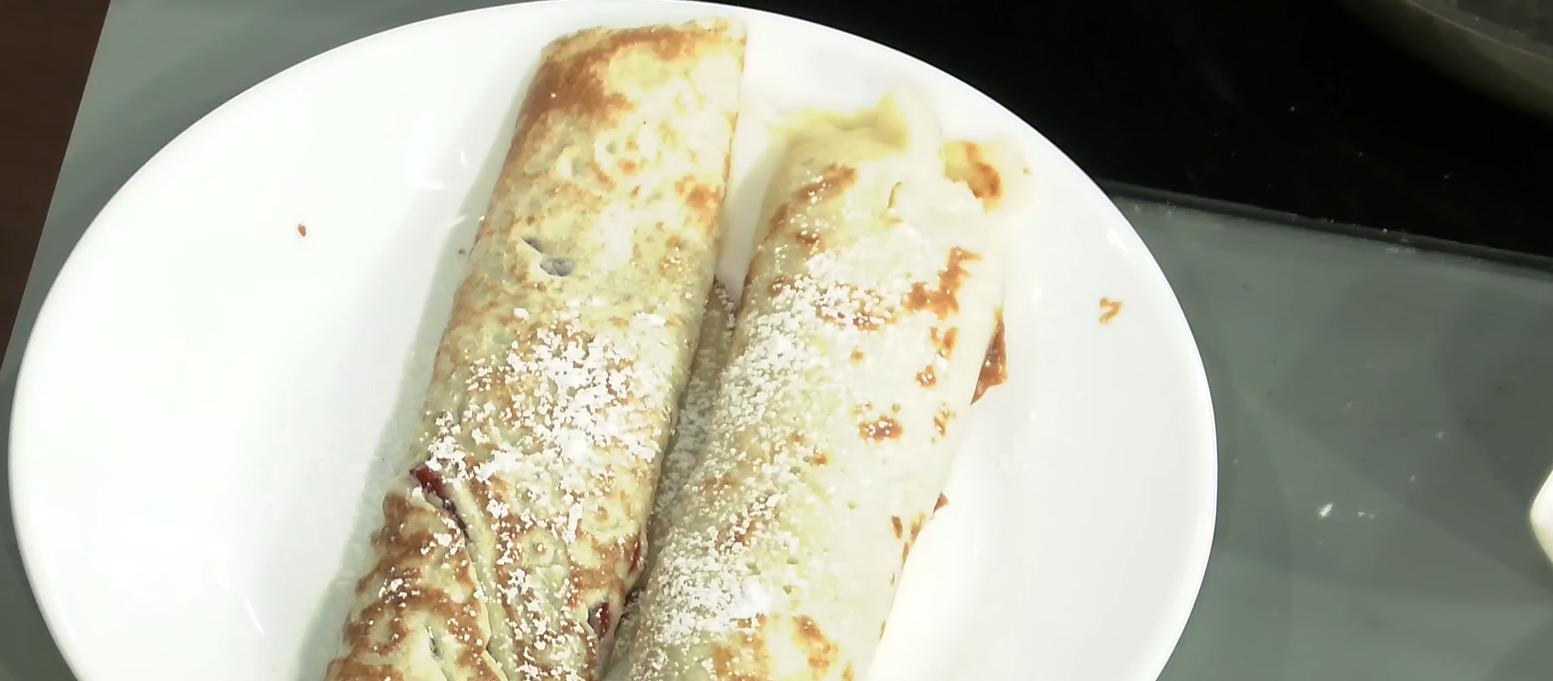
[326,20,744,681]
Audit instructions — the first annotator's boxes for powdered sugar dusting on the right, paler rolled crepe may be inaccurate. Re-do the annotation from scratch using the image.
[623,232,909,681]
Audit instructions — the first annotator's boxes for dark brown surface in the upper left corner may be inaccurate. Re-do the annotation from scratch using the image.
[0,0,109,347]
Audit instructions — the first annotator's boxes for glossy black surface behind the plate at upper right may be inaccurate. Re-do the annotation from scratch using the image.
[741,0,1553,256]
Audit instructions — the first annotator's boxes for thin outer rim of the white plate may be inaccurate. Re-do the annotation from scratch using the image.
[6,0,1219,681]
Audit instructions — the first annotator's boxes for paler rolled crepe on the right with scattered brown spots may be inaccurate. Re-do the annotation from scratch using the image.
[606,93,1028,681]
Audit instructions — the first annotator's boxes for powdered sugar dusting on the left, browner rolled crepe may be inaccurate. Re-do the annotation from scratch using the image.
[409,307,676,681]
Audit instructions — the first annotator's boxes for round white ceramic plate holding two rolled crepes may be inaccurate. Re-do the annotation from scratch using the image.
[11,0,1216,681]
